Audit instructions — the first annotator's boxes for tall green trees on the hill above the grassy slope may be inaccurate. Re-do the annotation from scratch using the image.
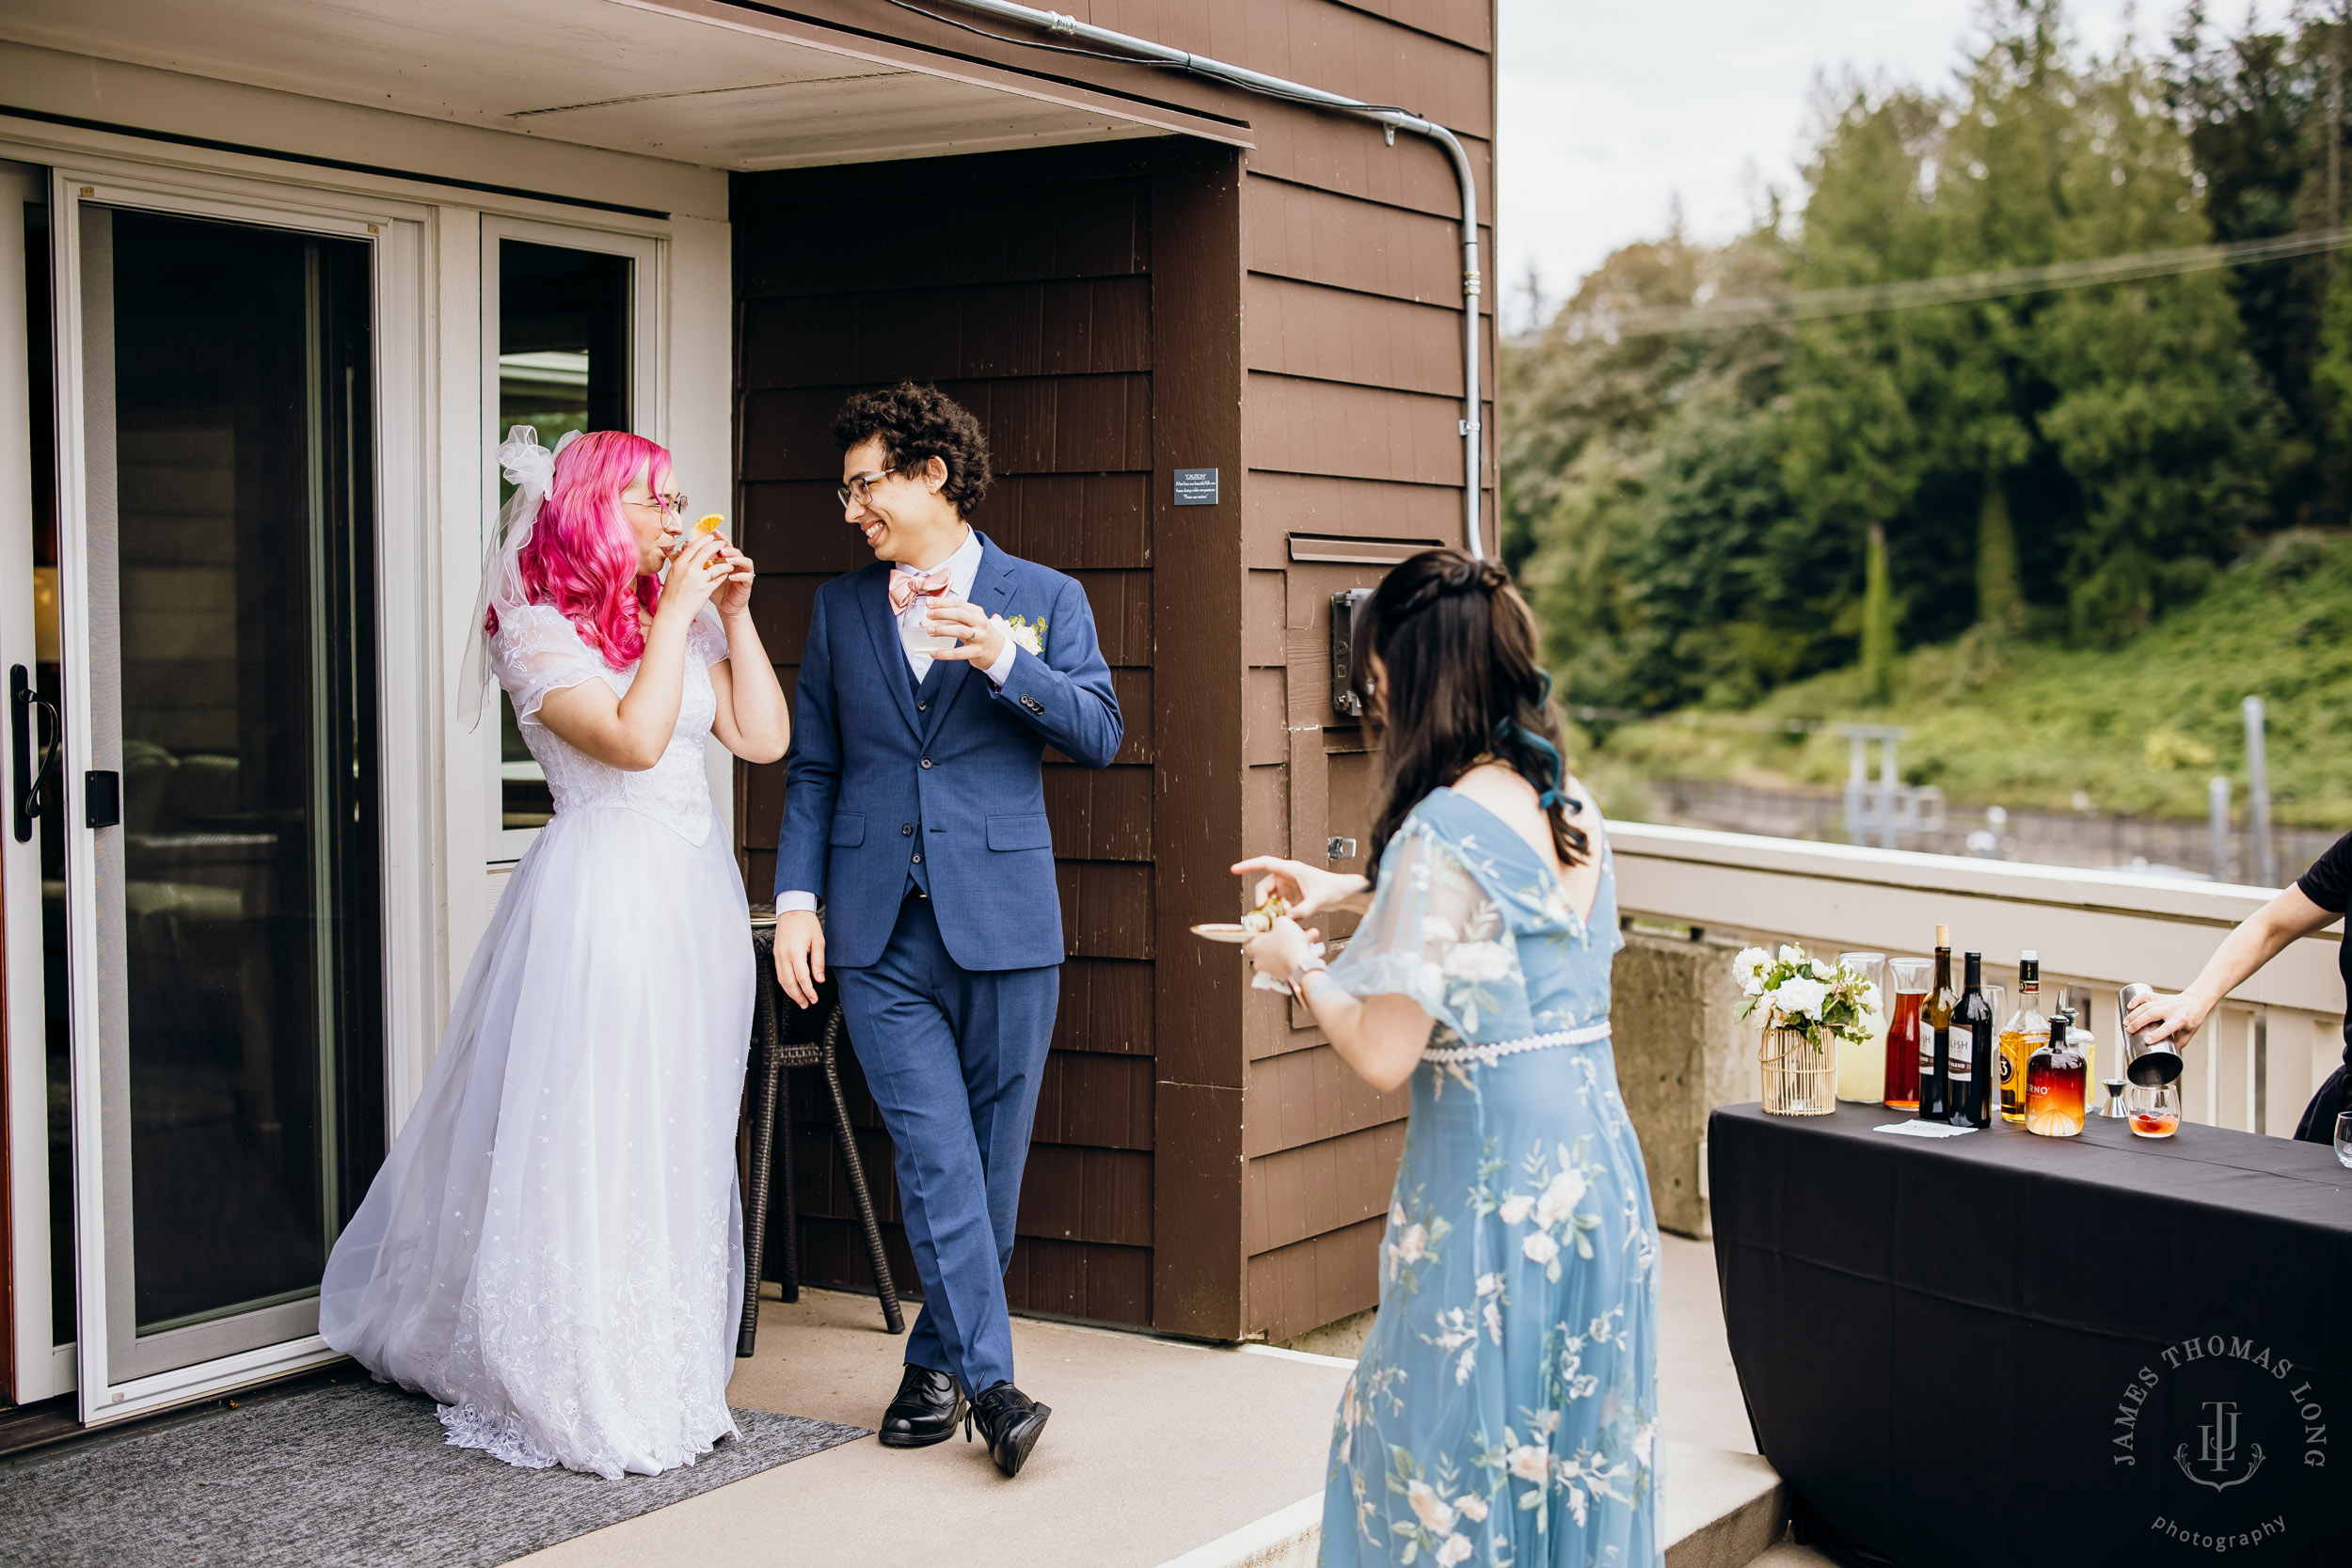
[1501,0,2305,712]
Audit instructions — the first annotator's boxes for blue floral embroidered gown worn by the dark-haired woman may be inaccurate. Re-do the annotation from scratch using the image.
[1322,790,1663,1568]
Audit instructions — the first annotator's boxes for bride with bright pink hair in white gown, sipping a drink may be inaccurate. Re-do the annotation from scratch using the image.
[318,425,790,1479]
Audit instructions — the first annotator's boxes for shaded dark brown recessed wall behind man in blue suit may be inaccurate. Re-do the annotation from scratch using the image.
[734,143,1240,1323]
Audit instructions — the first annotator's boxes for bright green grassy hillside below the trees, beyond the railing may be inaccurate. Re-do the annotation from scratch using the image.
[1579,533,2352,828]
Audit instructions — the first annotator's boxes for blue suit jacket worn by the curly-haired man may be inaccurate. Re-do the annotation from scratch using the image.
[776,533,1122,969]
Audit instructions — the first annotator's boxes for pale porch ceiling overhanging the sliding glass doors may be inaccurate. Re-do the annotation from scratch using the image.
[0,0,1247,169]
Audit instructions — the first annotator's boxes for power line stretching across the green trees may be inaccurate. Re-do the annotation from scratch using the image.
[1579,228,2352,343]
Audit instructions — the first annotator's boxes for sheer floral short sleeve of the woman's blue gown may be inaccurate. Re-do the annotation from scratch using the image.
[1331,818,1536,1044]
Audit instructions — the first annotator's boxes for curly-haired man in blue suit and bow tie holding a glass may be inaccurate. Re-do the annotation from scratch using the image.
[776,383,1122,1477]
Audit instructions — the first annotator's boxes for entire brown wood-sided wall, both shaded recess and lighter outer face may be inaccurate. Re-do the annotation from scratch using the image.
[734,0,1494,1340]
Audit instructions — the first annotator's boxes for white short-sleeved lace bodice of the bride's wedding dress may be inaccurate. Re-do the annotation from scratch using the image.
[489,604,727,844]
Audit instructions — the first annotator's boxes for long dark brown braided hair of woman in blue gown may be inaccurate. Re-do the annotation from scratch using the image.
[1348,547,1590,881]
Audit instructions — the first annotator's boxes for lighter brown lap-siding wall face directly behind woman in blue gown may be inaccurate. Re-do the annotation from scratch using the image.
[1223,0,1494,1340]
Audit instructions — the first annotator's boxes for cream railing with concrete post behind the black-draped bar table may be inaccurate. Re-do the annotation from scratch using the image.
[1612,823,2345,1234]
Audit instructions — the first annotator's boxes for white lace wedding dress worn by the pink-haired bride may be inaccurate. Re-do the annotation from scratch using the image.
[318,607,753,1479]
